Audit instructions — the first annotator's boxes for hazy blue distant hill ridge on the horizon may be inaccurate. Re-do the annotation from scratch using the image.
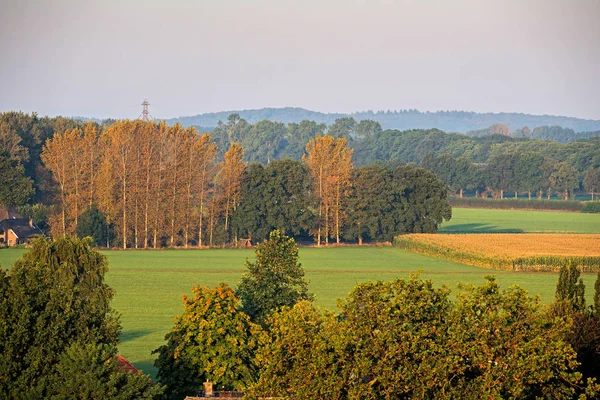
[166,107,600,133]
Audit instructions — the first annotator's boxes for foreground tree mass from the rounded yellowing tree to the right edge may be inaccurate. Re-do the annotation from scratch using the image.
[156,232,600,399]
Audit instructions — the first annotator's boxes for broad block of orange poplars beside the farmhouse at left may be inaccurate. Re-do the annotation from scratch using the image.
[42,120,217,248]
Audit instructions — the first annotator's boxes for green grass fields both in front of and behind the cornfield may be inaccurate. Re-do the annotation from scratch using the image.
[0,209,600,375]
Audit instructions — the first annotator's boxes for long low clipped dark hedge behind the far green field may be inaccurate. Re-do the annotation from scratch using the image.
[448,196,580,212]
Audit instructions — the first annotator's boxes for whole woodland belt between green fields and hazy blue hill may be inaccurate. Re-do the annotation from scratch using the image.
[0,112,600,248]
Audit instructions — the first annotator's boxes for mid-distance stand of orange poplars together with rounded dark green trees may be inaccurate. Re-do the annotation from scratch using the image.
[41,121,451,248]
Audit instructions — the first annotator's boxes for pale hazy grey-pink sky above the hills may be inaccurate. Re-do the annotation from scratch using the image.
[0,0,600,119]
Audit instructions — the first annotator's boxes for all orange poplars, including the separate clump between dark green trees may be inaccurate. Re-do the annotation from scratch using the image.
[41,120,352,248]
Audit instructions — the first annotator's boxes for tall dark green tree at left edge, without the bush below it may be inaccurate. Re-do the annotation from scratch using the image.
[0,237,120,398]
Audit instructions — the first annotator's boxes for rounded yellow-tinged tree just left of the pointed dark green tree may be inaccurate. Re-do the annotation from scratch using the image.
[154,283,261,399]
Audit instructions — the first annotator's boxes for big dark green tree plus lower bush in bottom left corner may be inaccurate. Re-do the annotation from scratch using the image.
[0,238,163,399]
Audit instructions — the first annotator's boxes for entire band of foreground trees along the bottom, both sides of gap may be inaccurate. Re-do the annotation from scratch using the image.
[0,231,600,399]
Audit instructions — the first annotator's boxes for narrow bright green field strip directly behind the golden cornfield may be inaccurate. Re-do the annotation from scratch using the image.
[439,208,600,233]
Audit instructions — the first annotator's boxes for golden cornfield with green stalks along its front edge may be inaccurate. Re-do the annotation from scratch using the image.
[394,234,600,272]
